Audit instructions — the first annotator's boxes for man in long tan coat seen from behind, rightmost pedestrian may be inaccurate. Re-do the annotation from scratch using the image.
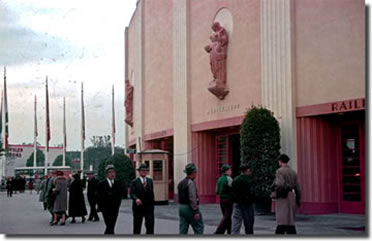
[272,154,301,234]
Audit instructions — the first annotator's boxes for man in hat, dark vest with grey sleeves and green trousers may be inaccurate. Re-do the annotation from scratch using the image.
[177,163,204,234]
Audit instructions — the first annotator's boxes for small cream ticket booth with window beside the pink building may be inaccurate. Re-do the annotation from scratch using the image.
[134,149,169,204]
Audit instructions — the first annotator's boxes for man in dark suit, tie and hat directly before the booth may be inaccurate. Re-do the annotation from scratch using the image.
[130,164,155,234]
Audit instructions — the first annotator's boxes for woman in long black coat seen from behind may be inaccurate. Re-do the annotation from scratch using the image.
[68,173,87,223]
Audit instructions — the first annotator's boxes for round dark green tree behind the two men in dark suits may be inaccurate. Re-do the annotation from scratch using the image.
[98,153,136,197]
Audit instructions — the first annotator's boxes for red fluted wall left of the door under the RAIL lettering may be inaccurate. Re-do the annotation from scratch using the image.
[297,117,339,214]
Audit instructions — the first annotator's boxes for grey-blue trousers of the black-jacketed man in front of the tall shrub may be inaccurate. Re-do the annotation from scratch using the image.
[232,203,254,234]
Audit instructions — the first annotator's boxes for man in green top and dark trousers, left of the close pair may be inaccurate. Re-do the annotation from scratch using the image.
[215,164,233,234]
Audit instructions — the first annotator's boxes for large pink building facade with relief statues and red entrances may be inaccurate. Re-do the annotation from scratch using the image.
[125,0,366,214]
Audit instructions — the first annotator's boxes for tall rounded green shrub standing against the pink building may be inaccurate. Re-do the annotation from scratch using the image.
[240,106,280,199]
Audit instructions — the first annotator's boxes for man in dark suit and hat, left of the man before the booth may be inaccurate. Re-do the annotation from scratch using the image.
[98,165,121,234]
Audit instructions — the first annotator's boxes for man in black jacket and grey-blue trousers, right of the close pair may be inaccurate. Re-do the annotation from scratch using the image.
[232,164,254,234]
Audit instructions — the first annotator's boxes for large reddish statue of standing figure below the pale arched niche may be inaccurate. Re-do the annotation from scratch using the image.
[204,22,229,100]
